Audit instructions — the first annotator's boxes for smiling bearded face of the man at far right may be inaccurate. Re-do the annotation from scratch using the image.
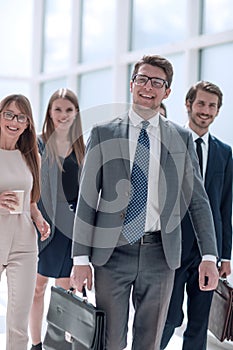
[186,90,219,136]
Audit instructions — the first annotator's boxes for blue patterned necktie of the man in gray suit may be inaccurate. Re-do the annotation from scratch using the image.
[122,120,150,244]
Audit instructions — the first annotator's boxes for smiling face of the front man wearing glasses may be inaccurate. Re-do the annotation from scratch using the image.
[130,64,171,119]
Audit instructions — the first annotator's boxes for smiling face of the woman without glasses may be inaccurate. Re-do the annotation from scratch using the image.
[50,98,77,131]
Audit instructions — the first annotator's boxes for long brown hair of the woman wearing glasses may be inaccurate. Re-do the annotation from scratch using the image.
[0,94,40,202]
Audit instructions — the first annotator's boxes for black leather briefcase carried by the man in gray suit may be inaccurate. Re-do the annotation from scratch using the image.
[43,286,106,350]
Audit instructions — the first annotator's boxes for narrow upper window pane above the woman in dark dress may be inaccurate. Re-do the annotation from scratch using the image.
[42,0,72,72]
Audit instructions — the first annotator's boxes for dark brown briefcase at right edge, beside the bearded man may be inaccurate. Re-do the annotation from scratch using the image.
[208,278,233,342]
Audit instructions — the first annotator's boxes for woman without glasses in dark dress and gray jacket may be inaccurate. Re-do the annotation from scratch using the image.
[30,89,84,350]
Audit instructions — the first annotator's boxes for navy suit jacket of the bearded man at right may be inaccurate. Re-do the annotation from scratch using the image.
[182,135,232,260]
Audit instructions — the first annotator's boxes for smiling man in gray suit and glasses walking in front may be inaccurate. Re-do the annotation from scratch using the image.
[71,55,218,350]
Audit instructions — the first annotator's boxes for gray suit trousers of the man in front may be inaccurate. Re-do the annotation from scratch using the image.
[94,242,174,350]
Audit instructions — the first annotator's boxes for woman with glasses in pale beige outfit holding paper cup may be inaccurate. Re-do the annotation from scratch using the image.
[0,95,50,350]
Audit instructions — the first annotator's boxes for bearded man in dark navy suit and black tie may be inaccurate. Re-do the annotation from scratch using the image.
[161,81,232,350]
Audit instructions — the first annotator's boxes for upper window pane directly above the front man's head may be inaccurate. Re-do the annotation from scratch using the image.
[131,0,187,50]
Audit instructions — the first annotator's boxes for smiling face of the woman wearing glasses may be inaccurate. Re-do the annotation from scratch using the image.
[0,101,29,149]
